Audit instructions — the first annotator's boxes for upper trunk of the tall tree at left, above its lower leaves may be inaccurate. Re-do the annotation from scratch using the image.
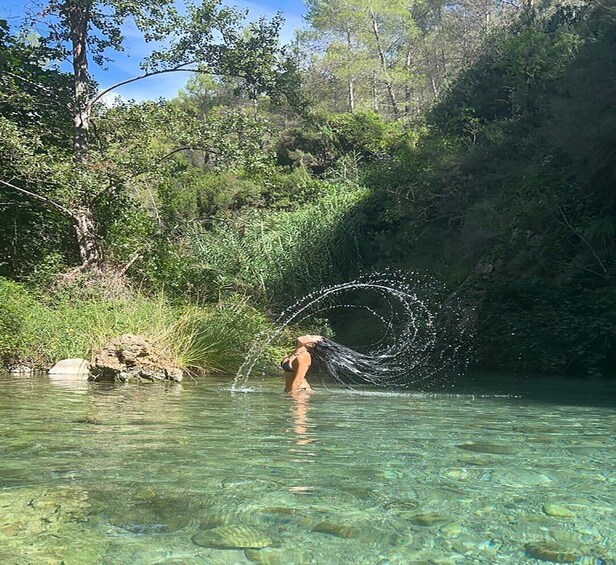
[62,0,92,161]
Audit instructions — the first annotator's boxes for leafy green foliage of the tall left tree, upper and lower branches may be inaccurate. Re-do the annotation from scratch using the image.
[0,0,299,270]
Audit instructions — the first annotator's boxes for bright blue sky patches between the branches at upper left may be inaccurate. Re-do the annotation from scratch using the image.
[0,0,305,101]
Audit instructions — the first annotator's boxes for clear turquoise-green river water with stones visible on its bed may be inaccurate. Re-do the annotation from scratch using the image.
[0,376,616,565]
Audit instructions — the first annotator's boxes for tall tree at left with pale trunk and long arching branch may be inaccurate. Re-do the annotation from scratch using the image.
[4,0,294,269]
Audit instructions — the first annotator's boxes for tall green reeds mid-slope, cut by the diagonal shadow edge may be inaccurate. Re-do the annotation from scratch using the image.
[189,184,368,304]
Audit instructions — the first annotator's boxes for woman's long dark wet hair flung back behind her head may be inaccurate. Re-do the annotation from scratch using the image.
[308,337,408,385]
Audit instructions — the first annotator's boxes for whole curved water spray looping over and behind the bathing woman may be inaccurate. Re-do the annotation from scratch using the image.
[232,271,470,391]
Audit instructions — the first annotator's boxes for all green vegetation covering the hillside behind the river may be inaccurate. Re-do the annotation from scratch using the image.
[0,0,616,376]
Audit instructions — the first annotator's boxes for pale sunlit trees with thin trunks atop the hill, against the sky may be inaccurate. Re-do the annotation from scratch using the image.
[300,0,534,118]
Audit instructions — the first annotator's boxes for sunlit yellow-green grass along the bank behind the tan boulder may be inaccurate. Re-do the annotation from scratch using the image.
[0,279,280,374]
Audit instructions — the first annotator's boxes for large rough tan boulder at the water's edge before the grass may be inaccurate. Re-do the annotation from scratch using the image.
[89,334,183,382]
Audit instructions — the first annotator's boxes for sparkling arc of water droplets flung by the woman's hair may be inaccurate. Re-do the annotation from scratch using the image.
[232,271,458,390]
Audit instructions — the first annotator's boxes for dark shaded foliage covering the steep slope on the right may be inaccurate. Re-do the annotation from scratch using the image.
[366,5,616,374]
